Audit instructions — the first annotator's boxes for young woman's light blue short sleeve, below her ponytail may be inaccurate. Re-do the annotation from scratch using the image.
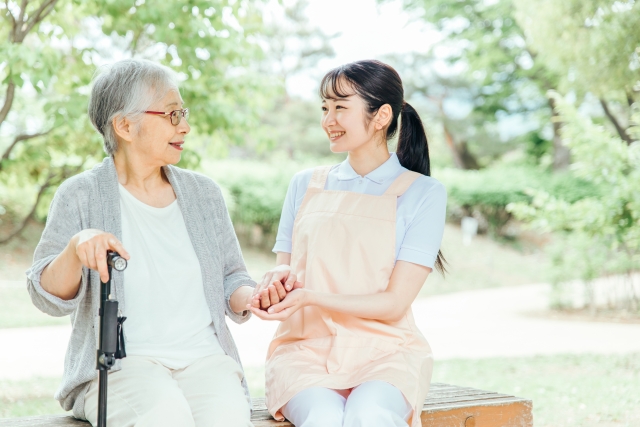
[398,181,447,268]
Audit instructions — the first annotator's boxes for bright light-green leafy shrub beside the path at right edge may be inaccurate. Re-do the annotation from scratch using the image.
[508,94,640,309]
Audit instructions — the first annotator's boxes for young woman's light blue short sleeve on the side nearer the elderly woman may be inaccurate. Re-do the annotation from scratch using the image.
[273,169,313,254]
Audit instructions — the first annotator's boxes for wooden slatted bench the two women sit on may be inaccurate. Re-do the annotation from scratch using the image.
[0,383,533,427]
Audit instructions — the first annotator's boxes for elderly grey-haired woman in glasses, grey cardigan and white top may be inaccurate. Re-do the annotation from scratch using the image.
[27,60,255,427]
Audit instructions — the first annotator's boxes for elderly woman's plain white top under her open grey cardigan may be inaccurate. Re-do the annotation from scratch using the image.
[119,185,224,369]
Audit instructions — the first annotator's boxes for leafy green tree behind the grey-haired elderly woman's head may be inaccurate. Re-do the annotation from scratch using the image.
[0,0,266,241]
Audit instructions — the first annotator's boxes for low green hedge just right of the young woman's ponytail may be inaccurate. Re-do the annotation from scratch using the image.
[435,165,599,236]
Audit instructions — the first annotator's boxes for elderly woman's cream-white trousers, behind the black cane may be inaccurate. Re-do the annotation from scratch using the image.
[84,354,253,427]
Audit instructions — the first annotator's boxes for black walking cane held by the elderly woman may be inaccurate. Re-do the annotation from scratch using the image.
[96,252,127,427]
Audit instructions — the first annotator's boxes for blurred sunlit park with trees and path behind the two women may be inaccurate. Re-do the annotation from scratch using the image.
[0,0,640,426]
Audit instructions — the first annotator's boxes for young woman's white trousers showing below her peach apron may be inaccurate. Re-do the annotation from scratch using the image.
[282,381,413,427]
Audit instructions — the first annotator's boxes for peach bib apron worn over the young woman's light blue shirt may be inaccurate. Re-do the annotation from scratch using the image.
[266,167,433,427]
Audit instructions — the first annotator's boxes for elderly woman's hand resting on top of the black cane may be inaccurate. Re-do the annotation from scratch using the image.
[71,228,131,282]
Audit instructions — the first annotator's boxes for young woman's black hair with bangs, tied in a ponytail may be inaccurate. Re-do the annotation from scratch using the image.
[320,60,447,275]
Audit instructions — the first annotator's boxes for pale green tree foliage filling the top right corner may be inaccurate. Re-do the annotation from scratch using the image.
[514,0,640,144]
